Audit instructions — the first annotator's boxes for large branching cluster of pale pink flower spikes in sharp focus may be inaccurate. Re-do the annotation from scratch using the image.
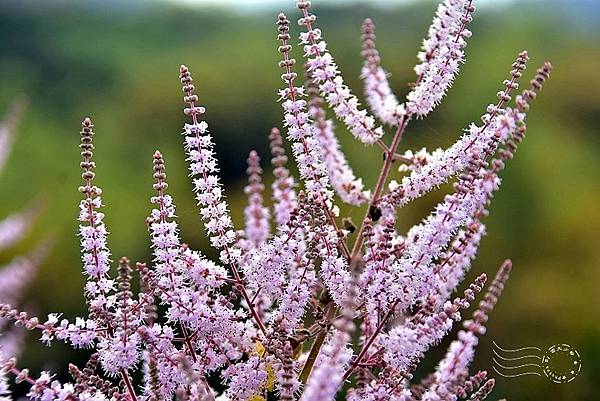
[0,0,551,401]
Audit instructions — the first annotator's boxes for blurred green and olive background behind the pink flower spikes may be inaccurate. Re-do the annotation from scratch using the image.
[0,0,600,401]
